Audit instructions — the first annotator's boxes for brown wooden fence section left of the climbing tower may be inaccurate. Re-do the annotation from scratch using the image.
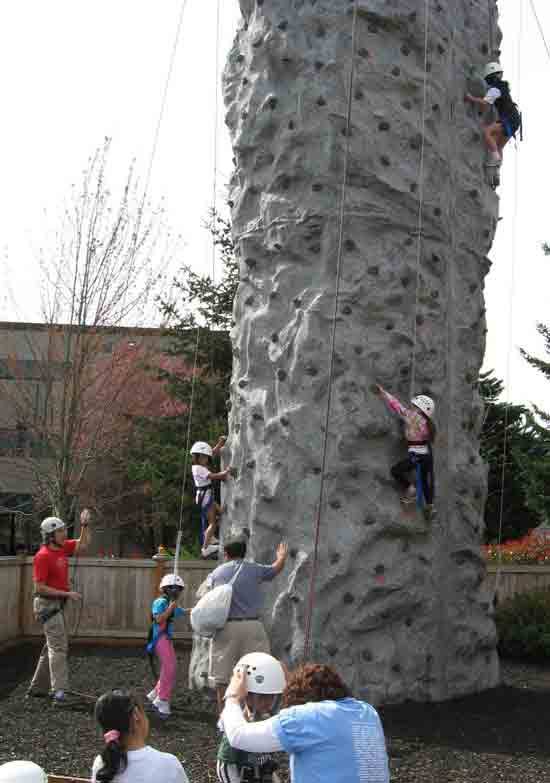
[0,557,215,643]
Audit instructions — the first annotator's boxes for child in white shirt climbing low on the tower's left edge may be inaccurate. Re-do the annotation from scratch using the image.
[191,436,231,558]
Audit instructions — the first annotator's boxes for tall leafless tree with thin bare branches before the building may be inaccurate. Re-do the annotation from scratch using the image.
[0,139,177,532]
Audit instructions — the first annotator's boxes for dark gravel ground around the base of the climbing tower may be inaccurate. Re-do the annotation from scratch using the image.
[0,644,550,783]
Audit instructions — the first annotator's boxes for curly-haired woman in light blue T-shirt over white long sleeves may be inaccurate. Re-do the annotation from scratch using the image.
[221,663,390,783]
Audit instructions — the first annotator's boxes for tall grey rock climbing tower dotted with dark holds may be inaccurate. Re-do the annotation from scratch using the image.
[224,0,500,703]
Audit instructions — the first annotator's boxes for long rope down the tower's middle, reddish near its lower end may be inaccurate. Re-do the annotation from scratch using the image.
[304,0,358,660]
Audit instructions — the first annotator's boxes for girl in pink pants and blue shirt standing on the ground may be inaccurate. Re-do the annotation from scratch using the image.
[147,574,185,718]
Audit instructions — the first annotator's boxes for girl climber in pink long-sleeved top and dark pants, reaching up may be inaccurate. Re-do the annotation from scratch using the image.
[375,385,436,519]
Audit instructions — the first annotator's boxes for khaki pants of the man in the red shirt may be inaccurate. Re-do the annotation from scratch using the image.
[30,596,69,693]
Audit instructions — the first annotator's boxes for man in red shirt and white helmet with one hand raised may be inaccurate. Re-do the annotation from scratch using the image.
[28,509,90,704]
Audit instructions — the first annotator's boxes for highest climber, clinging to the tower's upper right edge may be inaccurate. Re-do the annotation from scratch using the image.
[464,62,521,166]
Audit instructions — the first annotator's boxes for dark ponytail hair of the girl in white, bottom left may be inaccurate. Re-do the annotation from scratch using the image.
[95,690,140,783]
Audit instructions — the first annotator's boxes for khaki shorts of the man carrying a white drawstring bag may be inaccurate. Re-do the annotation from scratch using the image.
[208,620,271,685]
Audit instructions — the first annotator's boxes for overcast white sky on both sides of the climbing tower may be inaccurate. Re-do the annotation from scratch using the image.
[0,0,550,409]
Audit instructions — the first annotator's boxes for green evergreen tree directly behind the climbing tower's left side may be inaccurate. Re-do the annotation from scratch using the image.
[128,213,238,554]
